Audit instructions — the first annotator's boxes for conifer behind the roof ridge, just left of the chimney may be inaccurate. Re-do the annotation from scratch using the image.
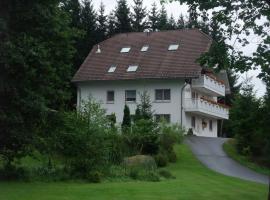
[132,0,146,32]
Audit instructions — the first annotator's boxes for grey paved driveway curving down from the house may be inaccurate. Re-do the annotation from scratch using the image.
[185,136,268,184]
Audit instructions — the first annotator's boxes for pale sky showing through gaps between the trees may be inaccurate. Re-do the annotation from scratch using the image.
[92,0,266,97]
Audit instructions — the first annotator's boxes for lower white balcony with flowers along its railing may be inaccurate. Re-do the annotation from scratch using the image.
[184,98,229,119]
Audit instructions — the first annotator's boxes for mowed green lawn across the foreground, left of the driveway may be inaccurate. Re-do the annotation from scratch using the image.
[0,144,268,200]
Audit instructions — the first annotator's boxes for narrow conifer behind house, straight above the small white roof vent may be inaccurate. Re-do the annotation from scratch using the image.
[97,2,107,42]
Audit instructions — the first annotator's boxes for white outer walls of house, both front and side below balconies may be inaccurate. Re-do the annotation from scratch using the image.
[77,79,217,137]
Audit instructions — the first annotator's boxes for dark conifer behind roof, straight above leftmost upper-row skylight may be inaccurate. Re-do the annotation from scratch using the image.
[115,0,132,33]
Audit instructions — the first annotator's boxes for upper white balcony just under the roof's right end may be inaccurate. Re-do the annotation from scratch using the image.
[192,74,225,96]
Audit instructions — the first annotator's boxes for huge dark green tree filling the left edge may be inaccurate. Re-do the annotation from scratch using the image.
[0,0,75,164]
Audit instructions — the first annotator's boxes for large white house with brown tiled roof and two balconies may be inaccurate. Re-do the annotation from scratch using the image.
[73,29,229,137]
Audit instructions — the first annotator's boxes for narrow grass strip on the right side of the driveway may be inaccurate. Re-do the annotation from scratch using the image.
[223,139,270,175]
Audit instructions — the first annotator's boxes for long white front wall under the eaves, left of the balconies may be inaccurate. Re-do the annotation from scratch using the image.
[77,79,184,123]
